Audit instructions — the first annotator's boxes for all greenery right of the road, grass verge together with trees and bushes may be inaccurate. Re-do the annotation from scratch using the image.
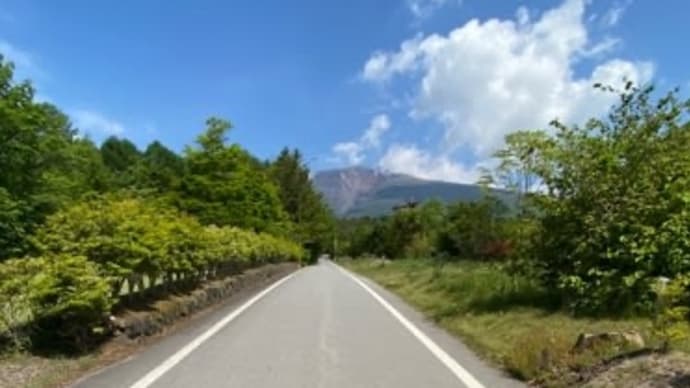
[339,83,690,381]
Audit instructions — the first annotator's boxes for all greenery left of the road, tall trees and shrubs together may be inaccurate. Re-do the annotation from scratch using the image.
[0,52,333,384]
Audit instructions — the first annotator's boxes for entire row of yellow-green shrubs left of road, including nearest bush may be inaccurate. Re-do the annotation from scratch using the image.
[0,196,305,347]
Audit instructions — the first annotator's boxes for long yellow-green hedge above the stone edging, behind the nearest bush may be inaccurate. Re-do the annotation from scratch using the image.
[36,195,304,295]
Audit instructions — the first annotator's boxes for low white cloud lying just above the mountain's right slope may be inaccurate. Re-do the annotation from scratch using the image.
[378,144,480,183]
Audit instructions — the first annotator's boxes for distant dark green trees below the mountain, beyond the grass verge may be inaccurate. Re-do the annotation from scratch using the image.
[340,197,516,259]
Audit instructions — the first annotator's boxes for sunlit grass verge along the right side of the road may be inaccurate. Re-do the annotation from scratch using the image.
[344,259,690,386]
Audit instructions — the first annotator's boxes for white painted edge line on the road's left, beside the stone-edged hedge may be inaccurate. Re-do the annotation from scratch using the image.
[130,271,300,388]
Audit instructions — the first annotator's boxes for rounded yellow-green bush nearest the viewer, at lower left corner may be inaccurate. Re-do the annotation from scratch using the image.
[0,254,113,347]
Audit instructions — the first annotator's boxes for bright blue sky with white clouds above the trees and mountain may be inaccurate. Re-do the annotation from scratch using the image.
[0,0,690,181]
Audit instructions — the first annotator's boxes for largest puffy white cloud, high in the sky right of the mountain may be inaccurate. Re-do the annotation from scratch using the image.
[362,0,654,160]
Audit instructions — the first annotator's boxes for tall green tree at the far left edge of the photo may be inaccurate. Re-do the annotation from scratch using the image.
[0,56,107,259]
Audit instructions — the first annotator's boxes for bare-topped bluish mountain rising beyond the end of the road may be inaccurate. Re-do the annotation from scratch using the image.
[313,167,510,217]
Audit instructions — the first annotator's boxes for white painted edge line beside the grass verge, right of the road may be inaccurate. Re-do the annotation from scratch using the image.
[331,262,484,388]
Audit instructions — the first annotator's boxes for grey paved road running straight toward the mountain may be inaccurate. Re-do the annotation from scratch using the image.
[77,262,520,388]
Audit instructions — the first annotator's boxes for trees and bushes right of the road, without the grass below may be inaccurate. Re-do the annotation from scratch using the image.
[341,83,690,315]
